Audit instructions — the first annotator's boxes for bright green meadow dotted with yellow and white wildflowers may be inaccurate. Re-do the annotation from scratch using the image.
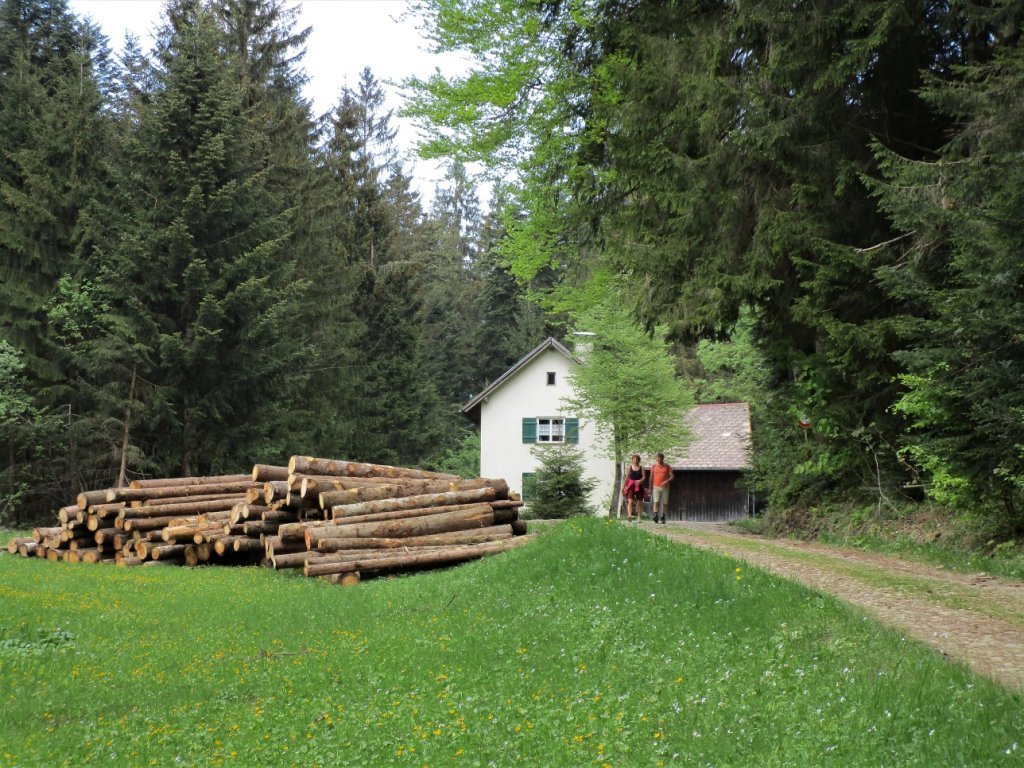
[0,519,1024,768]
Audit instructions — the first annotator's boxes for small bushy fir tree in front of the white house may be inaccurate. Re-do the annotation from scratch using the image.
[523,443,596,519]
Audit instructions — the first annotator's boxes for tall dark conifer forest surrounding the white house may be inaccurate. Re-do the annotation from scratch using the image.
[0,0,1024,537]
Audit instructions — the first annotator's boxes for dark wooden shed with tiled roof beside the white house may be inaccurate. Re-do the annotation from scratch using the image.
[647,402,752,522]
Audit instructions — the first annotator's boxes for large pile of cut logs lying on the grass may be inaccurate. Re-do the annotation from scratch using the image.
[7,456,532,584]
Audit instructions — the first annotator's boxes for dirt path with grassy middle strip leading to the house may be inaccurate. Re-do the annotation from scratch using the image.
[643,523,1024,692]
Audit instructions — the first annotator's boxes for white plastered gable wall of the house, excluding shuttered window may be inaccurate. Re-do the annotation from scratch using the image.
[480,349,615,514]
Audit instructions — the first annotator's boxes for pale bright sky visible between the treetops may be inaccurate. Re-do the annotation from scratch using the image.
[70,0,464,204]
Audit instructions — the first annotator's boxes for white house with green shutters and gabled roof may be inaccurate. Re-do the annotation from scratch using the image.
[462,338,615,514]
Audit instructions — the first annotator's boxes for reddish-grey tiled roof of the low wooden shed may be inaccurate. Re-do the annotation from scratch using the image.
[666,402,751,470]
